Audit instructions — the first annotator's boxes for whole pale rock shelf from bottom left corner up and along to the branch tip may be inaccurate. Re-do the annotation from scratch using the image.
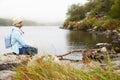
[0,54,60,80]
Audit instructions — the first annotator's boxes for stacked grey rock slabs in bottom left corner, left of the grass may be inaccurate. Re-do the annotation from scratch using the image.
[0,54,30,80]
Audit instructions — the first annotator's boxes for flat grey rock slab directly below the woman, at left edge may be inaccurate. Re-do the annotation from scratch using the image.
[0,55,30,70]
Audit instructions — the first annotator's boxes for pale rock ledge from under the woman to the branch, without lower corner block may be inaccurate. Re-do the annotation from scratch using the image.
[0,54,60,70]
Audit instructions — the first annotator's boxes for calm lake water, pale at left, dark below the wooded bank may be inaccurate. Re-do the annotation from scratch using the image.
[0,26,111,59]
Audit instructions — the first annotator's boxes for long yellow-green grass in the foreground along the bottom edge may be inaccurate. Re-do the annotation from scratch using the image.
[12,58,120,80]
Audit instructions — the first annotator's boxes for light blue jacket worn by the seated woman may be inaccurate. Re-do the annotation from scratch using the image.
[11,27,31,54]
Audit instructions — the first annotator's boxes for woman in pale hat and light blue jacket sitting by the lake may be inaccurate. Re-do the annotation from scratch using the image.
[11,17,38,55]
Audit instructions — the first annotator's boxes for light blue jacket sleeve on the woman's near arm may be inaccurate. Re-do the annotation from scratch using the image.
[13,31,31,47]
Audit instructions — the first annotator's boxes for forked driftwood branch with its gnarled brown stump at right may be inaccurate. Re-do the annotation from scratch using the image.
[56,47,120,64]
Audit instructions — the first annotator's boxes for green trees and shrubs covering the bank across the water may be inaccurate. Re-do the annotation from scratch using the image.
[63,0,120,31]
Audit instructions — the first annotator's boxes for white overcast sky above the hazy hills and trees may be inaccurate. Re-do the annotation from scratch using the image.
[0,0,87,22]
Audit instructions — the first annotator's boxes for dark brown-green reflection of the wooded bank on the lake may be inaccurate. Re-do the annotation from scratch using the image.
[67,31,112,49]
